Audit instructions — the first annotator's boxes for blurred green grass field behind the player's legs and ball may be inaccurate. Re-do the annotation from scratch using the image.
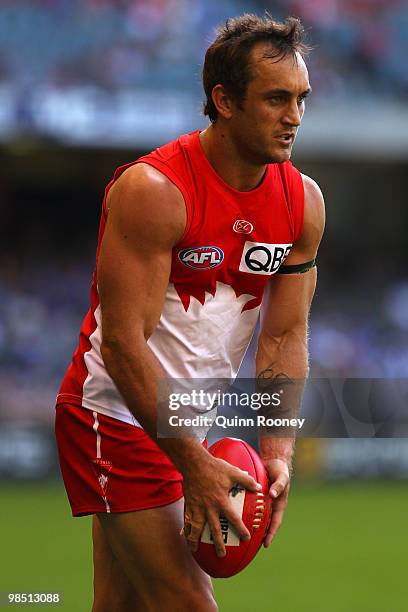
[0,483,408,612]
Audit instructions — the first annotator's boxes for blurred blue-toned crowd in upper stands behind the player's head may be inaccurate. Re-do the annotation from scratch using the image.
[0,0,408,140]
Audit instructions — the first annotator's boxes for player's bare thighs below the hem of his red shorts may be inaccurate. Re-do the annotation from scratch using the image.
[94,499,217,612]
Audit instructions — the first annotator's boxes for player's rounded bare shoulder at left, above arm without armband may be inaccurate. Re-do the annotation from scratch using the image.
[106,163,186,250]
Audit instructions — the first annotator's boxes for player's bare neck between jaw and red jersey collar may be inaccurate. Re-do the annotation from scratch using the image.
[200,123,266,191]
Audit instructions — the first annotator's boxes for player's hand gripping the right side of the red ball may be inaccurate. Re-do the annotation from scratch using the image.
[264,459,290,548]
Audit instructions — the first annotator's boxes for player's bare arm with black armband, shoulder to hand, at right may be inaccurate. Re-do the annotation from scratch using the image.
[256,176,325,546]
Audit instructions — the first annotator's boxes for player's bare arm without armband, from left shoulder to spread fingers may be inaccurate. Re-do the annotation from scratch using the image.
[97,164,256,553]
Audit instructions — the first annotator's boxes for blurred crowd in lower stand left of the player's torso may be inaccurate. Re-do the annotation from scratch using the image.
[0,257,91,422]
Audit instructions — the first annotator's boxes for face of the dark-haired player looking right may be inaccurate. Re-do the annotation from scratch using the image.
[230,44,310,164]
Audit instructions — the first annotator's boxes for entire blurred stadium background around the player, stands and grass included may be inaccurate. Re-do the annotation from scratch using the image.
[0,0,408,612]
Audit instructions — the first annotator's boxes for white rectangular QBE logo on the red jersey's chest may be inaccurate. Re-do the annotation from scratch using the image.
[239,240,292,275]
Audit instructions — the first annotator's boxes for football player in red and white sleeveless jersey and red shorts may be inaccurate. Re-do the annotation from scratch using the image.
[56,15,324,612]
